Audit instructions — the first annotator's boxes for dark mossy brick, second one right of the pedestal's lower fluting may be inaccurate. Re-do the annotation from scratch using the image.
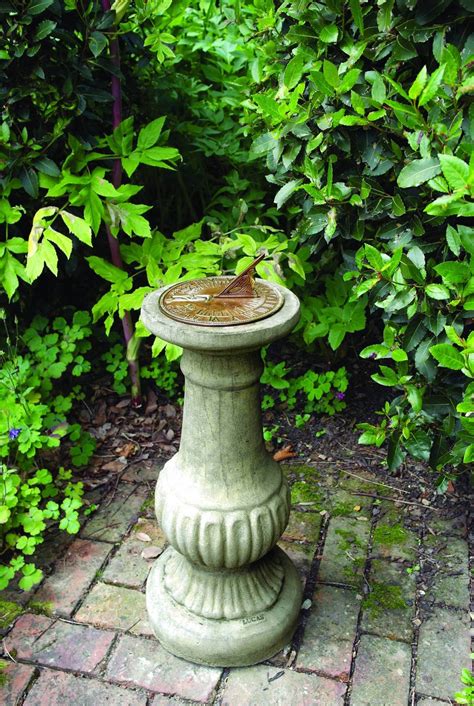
[317,517,369,586]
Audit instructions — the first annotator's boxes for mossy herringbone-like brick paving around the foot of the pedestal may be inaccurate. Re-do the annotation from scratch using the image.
[0,464,470,706]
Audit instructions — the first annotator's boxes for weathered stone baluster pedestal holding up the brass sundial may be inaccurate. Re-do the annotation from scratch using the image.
[142,285,301,667]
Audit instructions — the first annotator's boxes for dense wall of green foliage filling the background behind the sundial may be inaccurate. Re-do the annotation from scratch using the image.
[0,0,474,584]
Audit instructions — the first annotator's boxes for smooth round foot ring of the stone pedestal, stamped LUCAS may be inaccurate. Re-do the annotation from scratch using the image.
[146,547,302,667]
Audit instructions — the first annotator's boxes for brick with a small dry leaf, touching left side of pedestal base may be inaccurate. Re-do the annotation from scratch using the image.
[102,518,166,588]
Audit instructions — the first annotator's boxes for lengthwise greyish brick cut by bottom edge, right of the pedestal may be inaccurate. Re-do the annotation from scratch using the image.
[351,635,411,706]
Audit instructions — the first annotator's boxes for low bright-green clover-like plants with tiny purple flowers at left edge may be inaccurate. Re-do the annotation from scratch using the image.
[0,311,95,590]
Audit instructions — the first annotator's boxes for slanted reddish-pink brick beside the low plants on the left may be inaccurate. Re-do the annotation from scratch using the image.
[35,539,111,616]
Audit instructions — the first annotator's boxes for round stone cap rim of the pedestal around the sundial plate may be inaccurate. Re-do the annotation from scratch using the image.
[141,280,300,353]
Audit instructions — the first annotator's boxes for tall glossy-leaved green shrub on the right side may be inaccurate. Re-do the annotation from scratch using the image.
[234,0,474,478]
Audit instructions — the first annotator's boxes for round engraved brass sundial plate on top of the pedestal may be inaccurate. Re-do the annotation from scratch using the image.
[160,277,284,326]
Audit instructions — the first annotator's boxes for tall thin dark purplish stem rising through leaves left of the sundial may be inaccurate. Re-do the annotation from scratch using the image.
[102,0,142,407]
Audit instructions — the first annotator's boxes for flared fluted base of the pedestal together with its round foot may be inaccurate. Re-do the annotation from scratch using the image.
[146,547,302,667]
